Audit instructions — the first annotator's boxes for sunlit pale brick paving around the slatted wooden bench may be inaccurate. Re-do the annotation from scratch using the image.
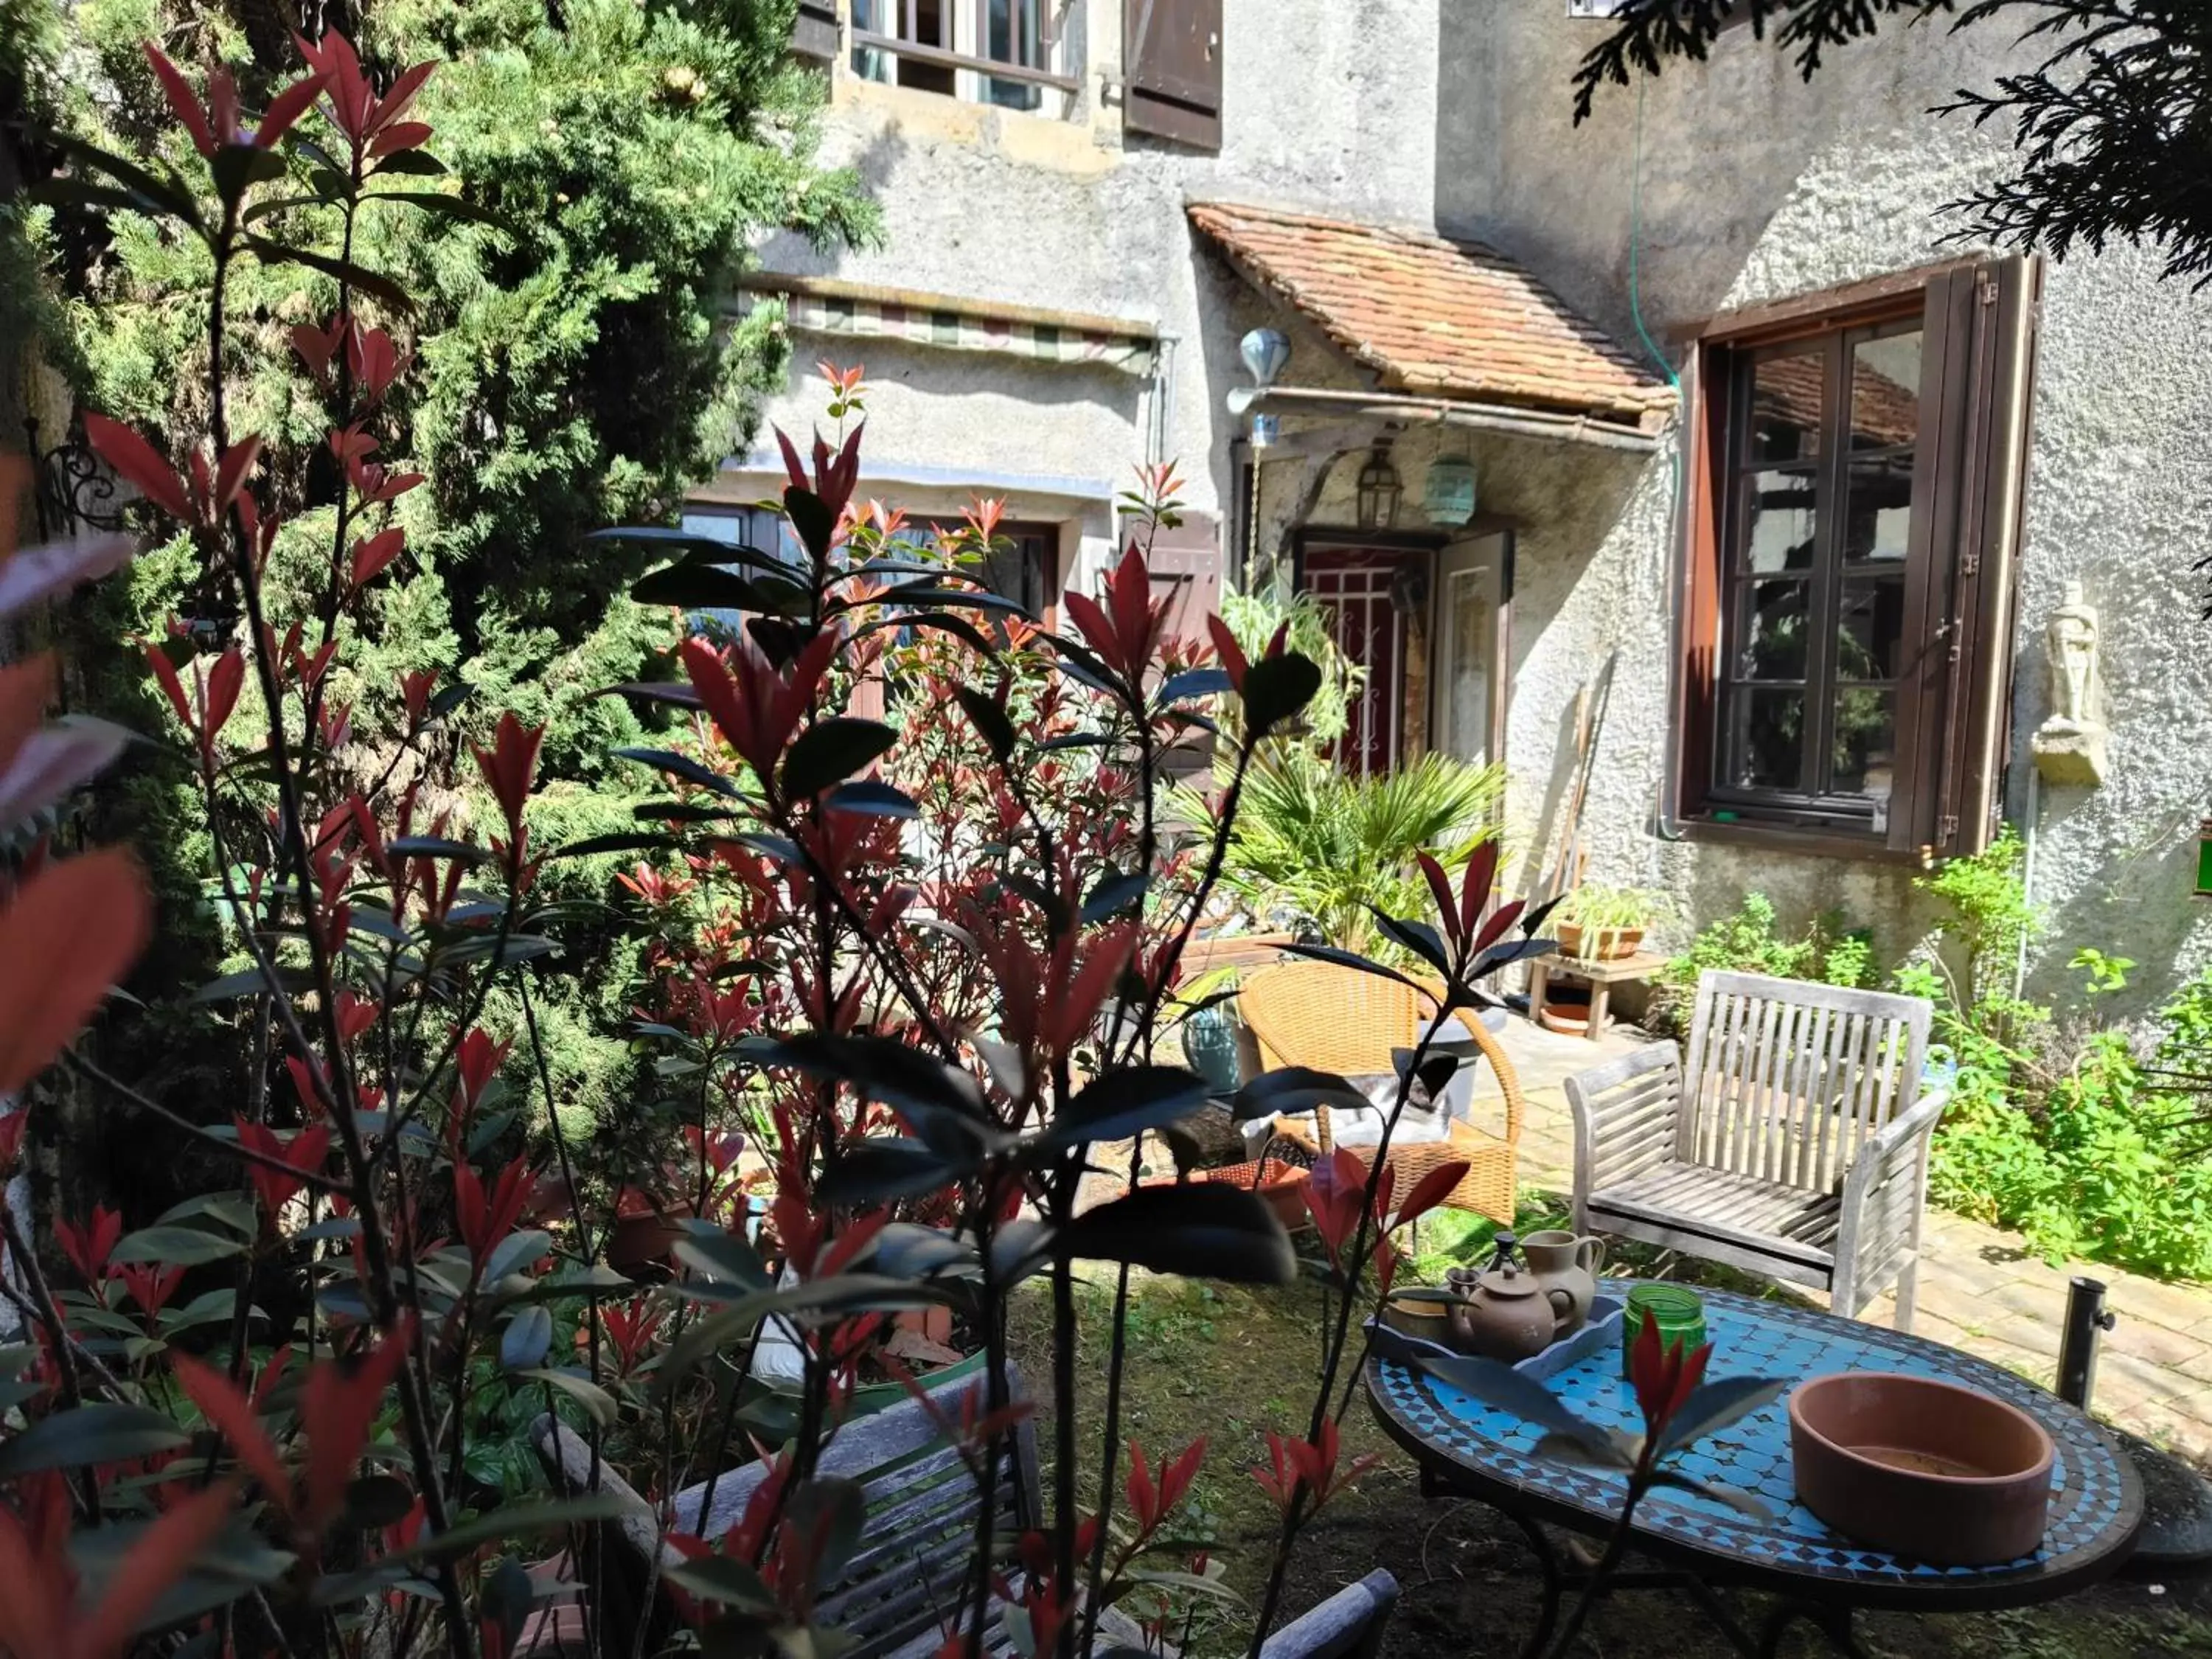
[1478,1020,2212,1464]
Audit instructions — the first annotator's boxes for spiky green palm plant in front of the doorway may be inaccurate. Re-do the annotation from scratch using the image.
[1223,743,1506,951]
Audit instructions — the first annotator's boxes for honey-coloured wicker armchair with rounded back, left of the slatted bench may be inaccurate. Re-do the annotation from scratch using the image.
[1237,962,1522,1225]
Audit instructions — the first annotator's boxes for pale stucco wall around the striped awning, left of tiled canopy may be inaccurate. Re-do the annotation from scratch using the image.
[734,0,1438,549]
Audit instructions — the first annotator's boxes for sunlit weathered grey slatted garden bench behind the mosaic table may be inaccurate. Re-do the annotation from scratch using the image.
[1566,973,1951,1329]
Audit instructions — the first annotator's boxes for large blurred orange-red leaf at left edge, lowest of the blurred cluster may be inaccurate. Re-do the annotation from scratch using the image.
[0,847,153,1095]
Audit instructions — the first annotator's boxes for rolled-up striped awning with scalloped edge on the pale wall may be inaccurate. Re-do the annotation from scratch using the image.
[739,270,1159,378]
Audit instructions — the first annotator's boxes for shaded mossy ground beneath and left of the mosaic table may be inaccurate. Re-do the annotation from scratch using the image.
[1011,1256,2212,1659]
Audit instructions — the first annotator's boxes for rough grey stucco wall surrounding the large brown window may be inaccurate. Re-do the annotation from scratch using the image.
[1438,19,2212,1011]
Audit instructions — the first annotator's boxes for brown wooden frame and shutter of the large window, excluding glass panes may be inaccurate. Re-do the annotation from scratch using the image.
[1672,257,2042,860]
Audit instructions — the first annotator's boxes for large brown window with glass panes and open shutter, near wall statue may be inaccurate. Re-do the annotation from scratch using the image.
[1681,259,2035,854]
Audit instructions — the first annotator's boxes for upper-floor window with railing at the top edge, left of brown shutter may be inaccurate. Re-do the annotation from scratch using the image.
[852,0,1082,113]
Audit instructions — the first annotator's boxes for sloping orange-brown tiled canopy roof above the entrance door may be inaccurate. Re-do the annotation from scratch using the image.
[1190,201,1674,425]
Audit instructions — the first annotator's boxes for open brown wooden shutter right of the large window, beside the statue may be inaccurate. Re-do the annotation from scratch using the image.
[1891,257,2042,858]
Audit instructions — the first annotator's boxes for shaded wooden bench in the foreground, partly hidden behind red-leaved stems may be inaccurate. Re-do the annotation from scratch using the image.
[531,1374,1398,1659]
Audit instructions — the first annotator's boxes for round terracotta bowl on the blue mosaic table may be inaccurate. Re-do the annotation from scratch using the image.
[1790,1371,2053,1566]
